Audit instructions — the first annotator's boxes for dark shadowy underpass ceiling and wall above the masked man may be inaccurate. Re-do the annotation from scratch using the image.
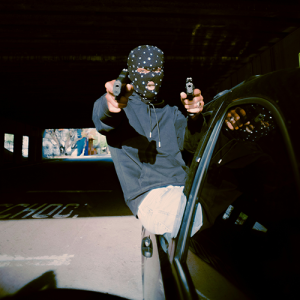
[0,0,300,131]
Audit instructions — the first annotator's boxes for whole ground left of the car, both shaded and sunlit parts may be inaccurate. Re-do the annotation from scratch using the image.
[0,157,143,300]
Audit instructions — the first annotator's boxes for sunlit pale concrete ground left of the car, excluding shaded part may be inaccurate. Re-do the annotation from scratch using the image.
[0,216,143,300]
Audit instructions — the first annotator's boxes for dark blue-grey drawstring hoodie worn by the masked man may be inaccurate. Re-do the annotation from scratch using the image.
[93,92,203,215]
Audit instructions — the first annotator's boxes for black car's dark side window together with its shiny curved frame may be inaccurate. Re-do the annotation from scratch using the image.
[173,97,300,299]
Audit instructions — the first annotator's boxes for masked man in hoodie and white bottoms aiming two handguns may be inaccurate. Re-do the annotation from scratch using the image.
[93,45,240,245]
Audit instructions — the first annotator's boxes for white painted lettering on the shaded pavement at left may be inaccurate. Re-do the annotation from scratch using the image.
[0,203,80,220]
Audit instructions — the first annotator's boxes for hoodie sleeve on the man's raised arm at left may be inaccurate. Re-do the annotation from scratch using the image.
[92,94,125,135]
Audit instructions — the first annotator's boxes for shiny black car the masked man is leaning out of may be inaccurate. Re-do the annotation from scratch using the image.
[142,68,300,300]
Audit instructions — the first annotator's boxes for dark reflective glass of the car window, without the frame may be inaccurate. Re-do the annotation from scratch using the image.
[187,104,300,299]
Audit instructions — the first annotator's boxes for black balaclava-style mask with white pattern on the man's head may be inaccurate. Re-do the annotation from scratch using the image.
[127,45,164,100]
